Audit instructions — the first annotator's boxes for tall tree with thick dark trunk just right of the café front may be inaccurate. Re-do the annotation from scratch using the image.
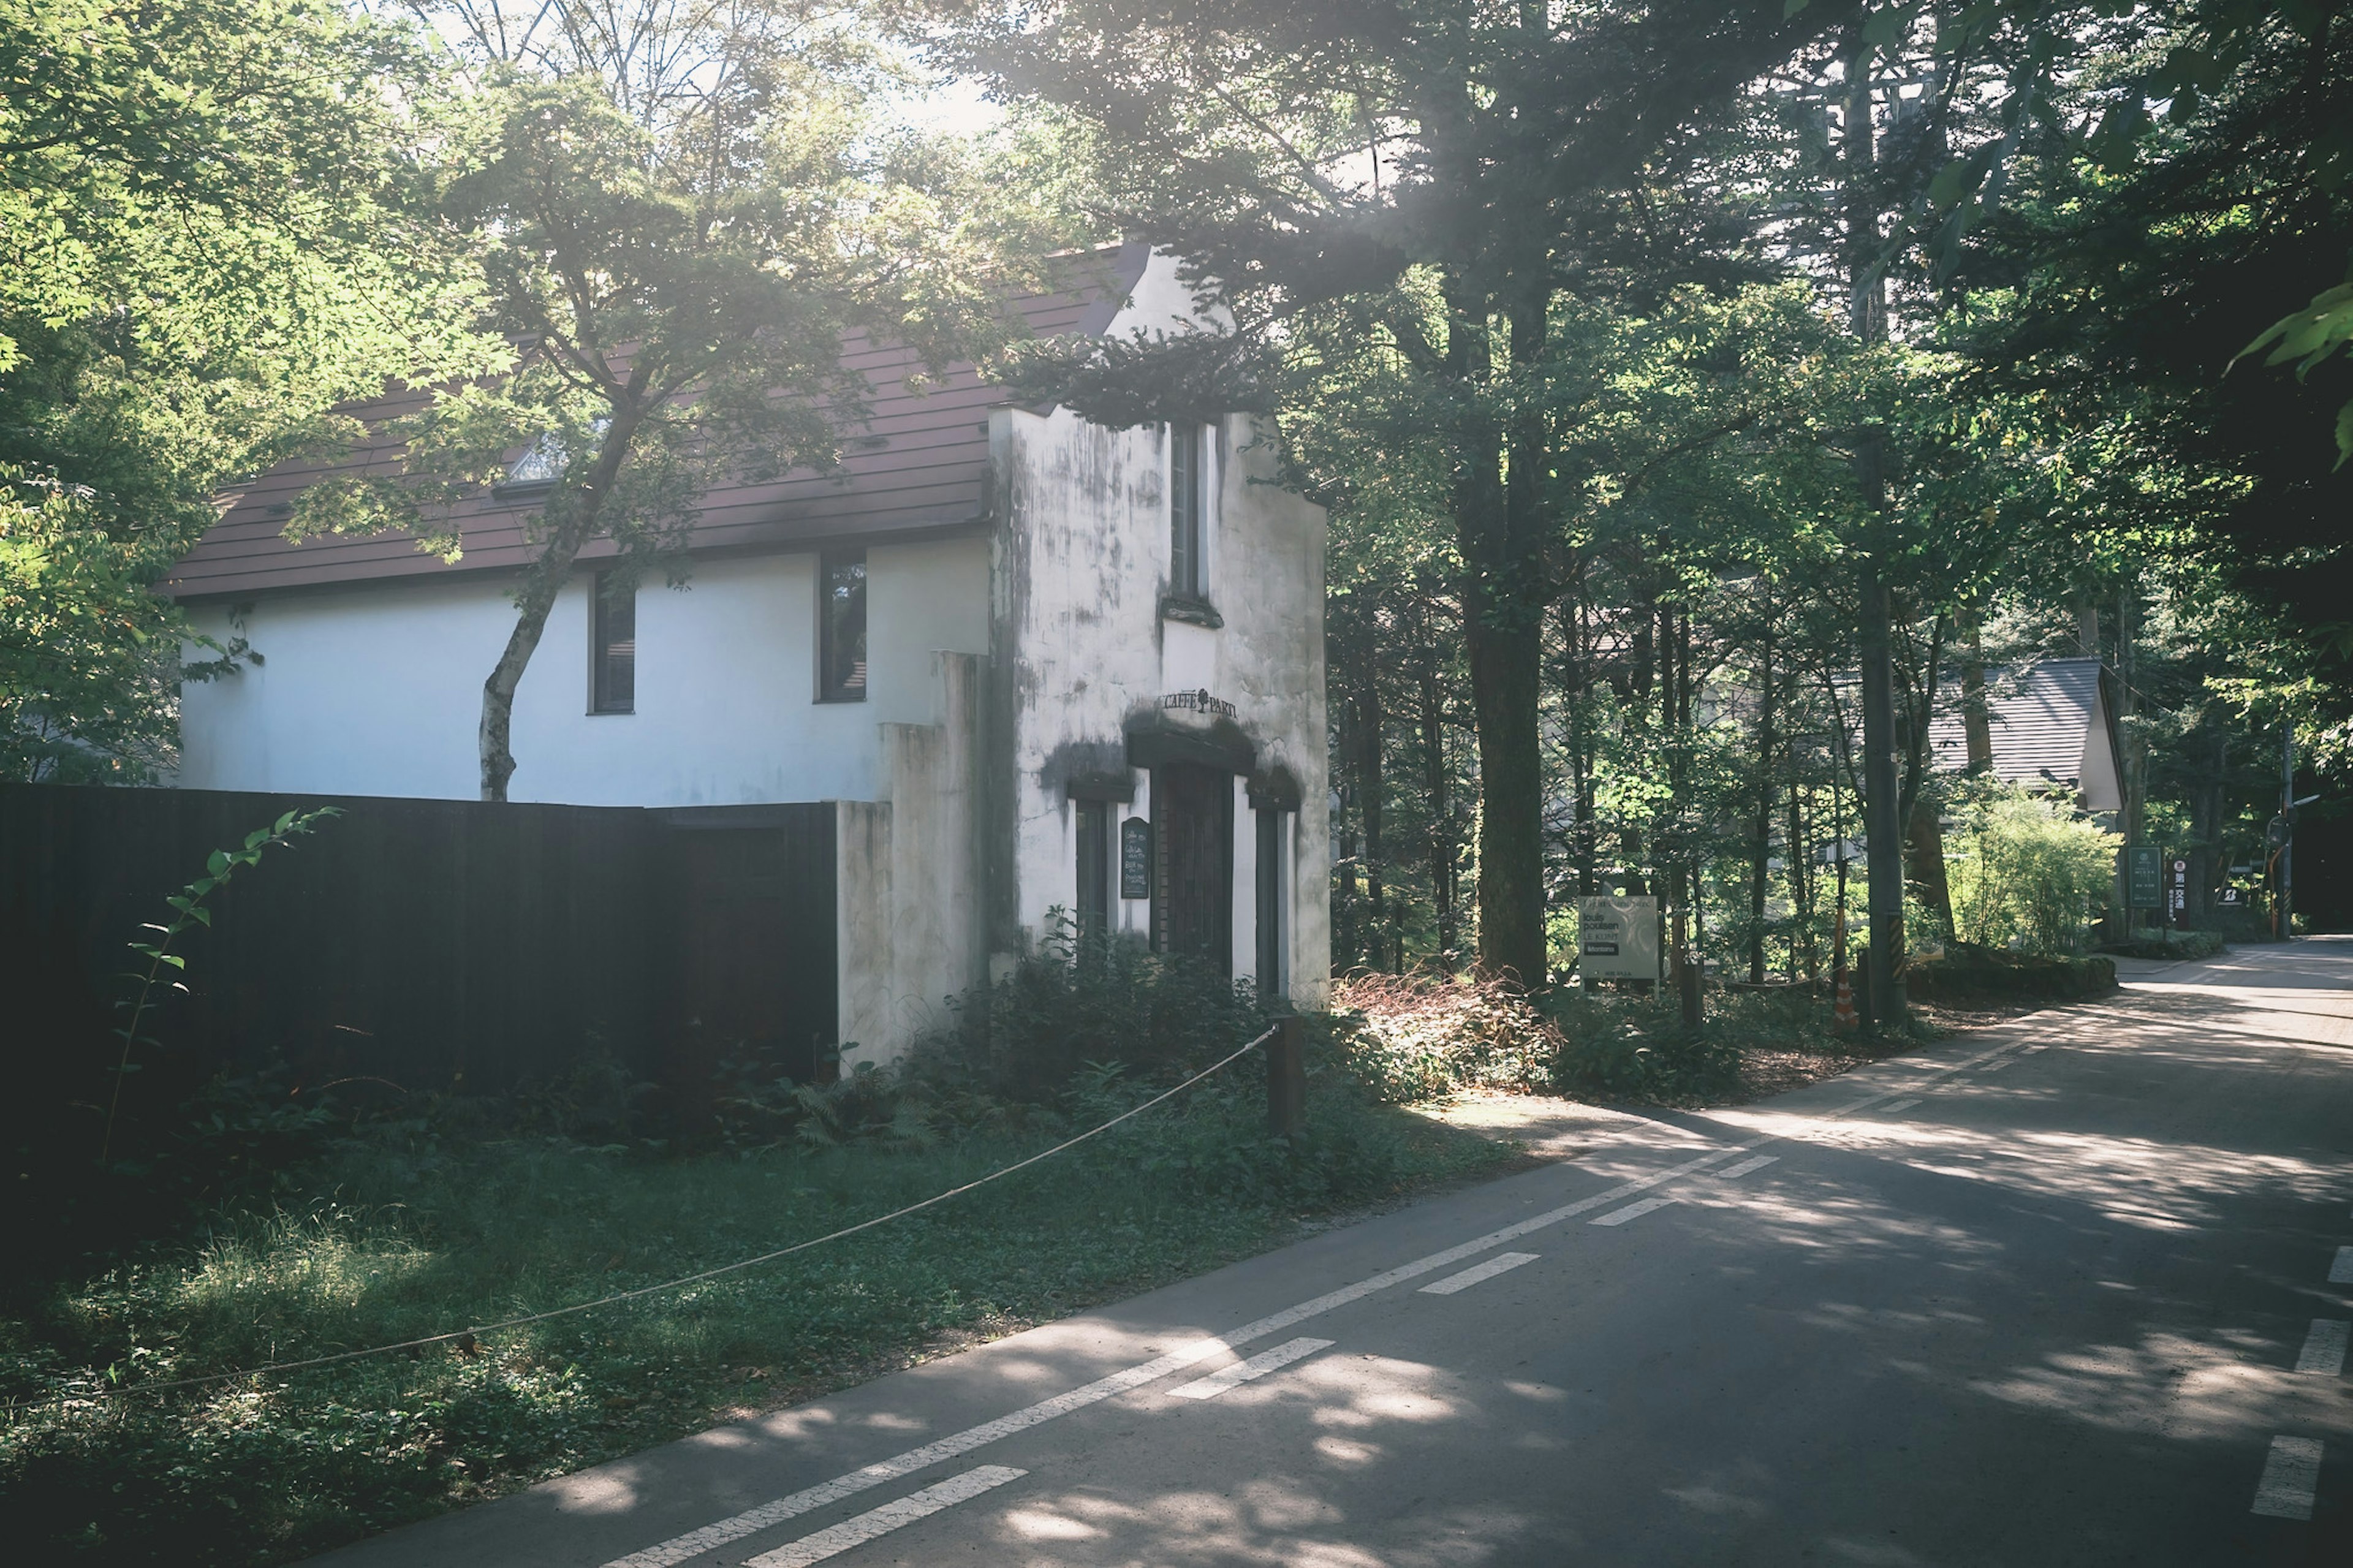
[955,0,1845,982]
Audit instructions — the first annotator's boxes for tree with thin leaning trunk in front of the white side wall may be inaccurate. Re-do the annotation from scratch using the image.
[294,0,1028,800]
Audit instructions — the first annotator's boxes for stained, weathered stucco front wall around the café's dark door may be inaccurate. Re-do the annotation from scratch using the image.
[991,384,1332,1006]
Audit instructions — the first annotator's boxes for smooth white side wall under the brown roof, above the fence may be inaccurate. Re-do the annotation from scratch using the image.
[179,537,988,805]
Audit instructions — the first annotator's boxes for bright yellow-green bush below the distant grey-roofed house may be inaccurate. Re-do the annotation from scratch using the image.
[1946,786,2123,958]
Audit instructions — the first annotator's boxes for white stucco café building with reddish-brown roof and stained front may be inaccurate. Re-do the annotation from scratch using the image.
[172,245,1330,1059]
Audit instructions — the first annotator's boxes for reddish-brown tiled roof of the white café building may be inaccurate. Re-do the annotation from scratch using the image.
[165,245,1148,598]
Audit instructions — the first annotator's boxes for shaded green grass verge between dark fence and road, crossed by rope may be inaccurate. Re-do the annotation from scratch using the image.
[0,1076,1510,1563]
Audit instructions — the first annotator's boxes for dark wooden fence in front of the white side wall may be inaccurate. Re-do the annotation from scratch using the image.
[0,784,835,1102]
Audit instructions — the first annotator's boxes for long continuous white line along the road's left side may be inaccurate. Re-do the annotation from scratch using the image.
[605,1026,2017,1568]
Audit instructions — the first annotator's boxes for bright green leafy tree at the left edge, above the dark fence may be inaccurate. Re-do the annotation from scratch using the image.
[0,0,490,779]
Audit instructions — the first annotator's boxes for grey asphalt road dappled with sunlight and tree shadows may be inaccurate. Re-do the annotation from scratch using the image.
[322,942,2353,1568]
